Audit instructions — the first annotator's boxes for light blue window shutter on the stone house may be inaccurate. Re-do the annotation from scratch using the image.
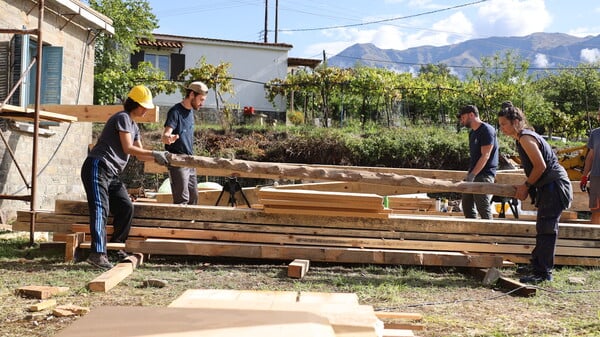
[40,46,63,104]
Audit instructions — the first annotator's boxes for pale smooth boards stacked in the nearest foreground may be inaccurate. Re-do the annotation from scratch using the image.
[57,289,422,337]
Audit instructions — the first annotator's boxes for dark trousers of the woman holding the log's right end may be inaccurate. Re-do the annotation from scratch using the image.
[531,182,563,276]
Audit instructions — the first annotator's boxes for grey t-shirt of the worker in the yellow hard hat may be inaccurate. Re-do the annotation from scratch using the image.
[88,111,140,174]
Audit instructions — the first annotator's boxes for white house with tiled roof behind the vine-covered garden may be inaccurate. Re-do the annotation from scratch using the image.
[131,34,319,120]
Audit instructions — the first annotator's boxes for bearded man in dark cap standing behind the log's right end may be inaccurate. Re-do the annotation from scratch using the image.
[458,105,498,220]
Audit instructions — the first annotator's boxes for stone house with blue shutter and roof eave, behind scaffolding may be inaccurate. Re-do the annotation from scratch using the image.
[0,0,114,223]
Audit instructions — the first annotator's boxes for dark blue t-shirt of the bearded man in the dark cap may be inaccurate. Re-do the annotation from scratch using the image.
[469,122,498,176]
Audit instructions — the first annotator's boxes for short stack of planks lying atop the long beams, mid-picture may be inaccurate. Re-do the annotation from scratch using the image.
[257,188,390,218]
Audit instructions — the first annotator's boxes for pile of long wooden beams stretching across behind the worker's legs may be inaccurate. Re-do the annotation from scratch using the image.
[13,200,600,268]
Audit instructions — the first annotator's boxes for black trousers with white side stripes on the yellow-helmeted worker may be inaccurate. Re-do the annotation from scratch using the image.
[81,158,133,253]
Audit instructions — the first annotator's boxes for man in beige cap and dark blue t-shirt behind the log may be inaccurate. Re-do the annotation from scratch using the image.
[161,81,208,205]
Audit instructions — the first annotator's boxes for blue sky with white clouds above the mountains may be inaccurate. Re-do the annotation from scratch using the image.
[148,0,600,62]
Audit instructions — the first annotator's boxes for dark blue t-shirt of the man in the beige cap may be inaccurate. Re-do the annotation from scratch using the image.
[165,103,194,155]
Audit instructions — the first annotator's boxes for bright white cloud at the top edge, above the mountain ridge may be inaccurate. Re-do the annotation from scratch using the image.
[475,0,552,37]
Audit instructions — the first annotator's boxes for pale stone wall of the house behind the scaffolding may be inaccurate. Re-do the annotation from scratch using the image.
[0,0,94,222]
